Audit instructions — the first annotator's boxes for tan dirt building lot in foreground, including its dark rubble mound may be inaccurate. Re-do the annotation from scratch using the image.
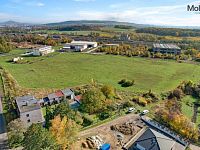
[75,114,144,150]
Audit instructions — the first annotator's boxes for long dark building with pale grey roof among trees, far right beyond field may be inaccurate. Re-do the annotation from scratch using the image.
[153,44,181,55]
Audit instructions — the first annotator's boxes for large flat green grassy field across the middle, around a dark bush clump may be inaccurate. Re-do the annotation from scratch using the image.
[0,50,200,93]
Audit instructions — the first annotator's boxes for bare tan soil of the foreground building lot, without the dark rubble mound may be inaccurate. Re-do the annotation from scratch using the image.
[74,113,144,150]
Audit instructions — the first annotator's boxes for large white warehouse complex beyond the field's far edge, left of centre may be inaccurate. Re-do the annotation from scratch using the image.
[62,41,98,52]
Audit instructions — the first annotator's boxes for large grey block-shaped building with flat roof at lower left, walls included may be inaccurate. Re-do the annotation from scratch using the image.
[16,95,45,126]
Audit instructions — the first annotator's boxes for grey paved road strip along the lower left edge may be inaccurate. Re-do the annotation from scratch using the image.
[0,96,8,150]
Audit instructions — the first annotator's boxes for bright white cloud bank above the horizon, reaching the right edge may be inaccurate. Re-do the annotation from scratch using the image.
[78,1,200,26]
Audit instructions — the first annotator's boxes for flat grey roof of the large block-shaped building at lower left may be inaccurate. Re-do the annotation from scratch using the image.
[16,95,41,113]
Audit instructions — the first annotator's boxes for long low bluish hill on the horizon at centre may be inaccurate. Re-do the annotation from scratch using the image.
[45,20,149,28]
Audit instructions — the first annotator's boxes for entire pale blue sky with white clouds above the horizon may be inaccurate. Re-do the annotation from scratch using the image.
[0,0,200,26]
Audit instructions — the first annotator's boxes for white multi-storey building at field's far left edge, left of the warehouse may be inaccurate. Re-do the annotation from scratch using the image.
[32,46,54,56]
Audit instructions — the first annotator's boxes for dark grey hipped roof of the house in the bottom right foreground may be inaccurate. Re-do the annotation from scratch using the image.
[124,127,186,150]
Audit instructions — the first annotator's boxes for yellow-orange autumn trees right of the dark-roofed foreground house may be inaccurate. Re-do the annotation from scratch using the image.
[155,99,198,141]
